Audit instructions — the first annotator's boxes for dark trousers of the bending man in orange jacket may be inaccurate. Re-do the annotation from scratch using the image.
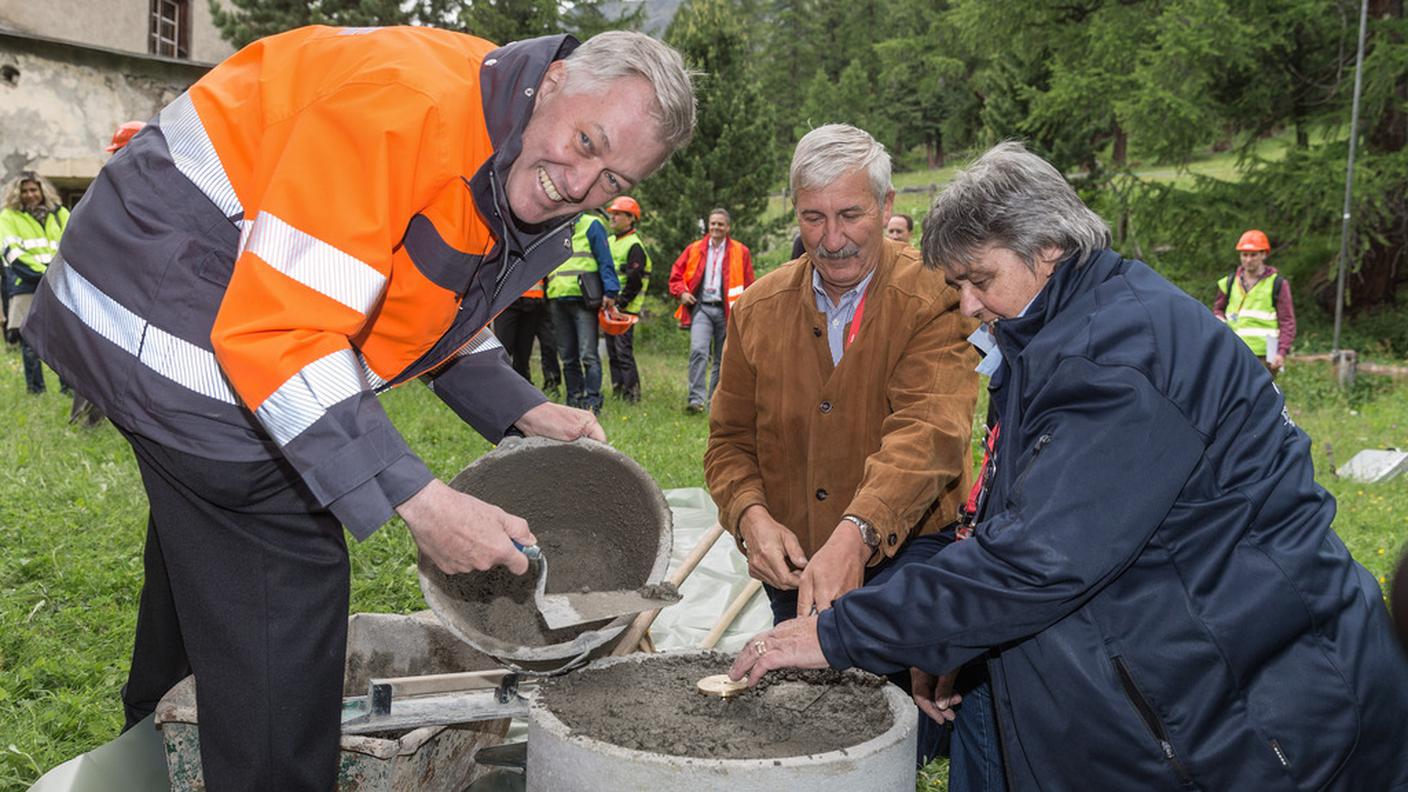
[122,434,349,792]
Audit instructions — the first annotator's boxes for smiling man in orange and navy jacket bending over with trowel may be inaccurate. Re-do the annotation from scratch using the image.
[24,27,694,791]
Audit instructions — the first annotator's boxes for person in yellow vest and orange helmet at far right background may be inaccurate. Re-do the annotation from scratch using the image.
[1212,228,1295,376]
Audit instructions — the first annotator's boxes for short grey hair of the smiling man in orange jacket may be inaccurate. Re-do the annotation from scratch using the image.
[563,30,694,151]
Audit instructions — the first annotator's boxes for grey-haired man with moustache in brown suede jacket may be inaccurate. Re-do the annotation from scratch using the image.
[704,124,977,621]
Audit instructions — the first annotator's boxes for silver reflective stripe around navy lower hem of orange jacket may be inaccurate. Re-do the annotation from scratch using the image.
[45,259,239,404]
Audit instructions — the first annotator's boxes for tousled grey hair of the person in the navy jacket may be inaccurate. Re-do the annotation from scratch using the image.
[922,141,1110,271]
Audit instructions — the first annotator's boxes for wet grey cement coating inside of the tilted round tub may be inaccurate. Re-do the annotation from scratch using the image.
[445,445,660,647]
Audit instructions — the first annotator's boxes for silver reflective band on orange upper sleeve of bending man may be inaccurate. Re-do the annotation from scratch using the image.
[242,211,386,314]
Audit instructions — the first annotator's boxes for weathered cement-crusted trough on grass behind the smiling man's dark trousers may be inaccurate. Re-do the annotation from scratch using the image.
[156,612,508,792]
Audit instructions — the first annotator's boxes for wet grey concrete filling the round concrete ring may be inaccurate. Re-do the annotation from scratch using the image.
[538,652,894,760]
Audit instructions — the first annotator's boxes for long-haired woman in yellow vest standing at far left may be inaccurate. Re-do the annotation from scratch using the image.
[0,171,69,393]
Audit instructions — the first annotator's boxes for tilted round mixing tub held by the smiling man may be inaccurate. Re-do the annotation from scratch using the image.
[420,437,673,674]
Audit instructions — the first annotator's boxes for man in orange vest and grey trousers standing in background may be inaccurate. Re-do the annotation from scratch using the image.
[669,209,753,413]
